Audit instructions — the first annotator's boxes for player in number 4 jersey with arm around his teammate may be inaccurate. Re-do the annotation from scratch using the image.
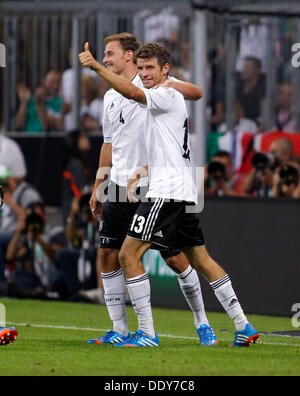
[82,33,217,345]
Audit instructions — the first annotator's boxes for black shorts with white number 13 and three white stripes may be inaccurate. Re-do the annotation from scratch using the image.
[127,198,205,252]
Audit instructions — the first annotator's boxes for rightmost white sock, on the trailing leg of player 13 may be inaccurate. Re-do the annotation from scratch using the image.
[210,275,248,331]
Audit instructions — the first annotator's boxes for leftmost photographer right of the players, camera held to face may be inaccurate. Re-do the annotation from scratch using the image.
[205,151,237,197]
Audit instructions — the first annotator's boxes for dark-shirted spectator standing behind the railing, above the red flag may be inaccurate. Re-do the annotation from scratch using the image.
[236,57,265,125]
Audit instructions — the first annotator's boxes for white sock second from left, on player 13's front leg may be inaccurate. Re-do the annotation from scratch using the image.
[126,273,155,338]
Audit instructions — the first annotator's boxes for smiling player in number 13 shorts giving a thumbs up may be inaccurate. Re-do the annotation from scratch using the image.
[79,39,259,347]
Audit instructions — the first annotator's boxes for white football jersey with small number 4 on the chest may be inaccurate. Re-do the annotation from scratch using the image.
[102,74,148,187]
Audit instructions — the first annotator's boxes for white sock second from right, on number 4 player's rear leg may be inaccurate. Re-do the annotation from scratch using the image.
[177,266,209,329]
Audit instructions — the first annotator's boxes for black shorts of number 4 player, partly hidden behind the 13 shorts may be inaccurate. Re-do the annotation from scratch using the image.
[99,183,185,259]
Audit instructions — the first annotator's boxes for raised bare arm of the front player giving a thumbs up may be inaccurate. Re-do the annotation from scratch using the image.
[79,43,147,104]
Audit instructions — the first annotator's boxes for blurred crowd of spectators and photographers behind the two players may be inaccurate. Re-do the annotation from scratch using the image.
[0,10,300,302]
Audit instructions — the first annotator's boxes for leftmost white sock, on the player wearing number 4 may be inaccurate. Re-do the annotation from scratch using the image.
[101,269,128,335]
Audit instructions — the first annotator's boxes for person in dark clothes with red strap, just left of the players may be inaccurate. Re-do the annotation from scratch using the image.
[62,130,91,220]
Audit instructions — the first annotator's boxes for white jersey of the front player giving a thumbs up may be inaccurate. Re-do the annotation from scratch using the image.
[143,87,197,203]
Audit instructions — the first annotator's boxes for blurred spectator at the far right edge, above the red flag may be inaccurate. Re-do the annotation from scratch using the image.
[275,82,296,133]
